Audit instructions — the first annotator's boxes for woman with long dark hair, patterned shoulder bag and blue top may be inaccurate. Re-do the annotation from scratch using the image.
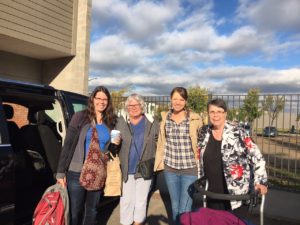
[56,86,120,225]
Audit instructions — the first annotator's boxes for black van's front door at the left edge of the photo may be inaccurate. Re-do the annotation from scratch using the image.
[0,99,15,225]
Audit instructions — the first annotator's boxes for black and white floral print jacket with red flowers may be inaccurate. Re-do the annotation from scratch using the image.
[198,121,267,209]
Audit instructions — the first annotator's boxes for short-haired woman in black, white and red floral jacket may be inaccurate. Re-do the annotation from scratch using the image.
[198,99,267,211]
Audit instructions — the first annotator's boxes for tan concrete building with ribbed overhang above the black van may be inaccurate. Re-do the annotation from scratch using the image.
[0,0,91,94]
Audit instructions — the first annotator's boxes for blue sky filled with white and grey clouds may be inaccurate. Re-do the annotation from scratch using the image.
[89,0,300,95]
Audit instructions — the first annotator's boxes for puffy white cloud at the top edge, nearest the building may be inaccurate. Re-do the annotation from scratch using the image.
[93,0,180,40]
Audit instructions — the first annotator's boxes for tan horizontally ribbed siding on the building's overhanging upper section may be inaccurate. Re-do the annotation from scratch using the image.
[0,0,74,53]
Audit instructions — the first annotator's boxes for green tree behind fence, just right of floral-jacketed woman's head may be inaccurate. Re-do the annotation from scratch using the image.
[242,88,262,124]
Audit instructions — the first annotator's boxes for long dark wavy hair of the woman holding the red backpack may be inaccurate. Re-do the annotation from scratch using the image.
[87,86,116,129]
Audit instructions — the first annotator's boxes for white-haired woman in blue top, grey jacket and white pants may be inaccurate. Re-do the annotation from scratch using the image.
[115,94,159,225]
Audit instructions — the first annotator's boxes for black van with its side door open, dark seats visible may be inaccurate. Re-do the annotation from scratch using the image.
[0,80,87,225]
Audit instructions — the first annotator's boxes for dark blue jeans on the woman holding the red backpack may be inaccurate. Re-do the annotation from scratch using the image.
[67,171,101,225]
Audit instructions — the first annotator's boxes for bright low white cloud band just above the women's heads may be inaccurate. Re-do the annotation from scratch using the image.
[91,66,300,95]
